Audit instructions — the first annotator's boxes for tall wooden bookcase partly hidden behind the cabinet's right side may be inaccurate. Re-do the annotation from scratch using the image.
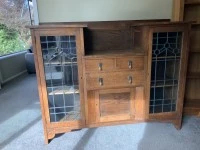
[172,0,200,116]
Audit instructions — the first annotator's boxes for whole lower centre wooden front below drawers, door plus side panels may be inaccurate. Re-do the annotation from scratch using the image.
[86,86,146,126]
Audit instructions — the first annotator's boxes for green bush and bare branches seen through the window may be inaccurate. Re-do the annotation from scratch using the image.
[0,0,30,56]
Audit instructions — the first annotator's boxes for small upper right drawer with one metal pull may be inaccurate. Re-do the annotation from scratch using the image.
[116,57,144,70]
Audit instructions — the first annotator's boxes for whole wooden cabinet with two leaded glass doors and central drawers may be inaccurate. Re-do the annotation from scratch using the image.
[30,22,189,142]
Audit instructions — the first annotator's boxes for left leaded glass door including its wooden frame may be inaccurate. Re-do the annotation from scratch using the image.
[36,29,85,128]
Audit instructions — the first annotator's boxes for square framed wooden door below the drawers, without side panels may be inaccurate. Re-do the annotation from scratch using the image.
[95,88,135,122]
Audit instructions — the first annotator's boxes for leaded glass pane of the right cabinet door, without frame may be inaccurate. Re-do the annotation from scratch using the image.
[150,32,182,113]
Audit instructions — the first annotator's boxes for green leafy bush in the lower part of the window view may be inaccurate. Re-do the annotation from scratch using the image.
[0,25,27,56]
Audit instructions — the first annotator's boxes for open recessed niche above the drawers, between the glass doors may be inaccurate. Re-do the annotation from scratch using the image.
[84,26,146,57]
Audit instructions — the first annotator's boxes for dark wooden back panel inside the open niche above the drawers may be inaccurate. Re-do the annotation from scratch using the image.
[85,29,132,53]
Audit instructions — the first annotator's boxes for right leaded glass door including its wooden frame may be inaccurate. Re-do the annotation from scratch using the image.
[149,27,188,118]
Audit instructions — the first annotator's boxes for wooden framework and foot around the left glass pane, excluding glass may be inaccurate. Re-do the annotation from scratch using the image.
[32,27,85,143]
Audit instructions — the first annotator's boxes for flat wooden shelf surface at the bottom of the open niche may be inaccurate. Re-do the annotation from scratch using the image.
[85,48,146,57]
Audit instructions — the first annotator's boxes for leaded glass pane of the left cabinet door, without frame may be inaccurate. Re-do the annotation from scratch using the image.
[40,36,80,122]
